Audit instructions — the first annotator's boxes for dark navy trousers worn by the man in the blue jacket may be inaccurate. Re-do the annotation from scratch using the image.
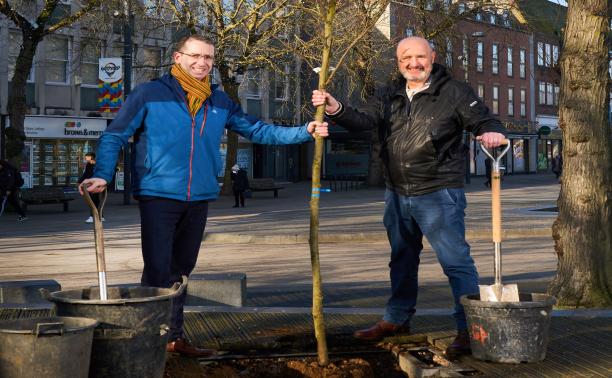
[139,198,208,340]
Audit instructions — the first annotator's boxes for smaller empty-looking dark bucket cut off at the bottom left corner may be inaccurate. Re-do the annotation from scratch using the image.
[0,317,98,378]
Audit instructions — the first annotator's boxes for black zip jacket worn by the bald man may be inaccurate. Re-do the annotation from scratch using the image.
[330,64,505,196]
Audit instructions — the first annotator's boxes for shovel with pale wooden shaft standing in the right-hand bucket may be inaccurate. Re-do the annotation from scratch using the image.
[478,139,520,302]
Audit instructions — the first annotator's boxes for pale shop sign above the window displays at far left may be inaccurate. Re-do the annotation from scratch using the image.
[23,116,106,139]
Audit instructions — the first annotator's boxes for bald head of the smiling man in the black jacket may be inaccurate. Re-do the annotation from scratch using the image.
[396,37,436,89]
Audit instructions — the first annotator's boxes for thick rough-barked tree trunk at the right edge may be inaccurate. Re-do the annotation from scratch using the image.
[550,0,612,307]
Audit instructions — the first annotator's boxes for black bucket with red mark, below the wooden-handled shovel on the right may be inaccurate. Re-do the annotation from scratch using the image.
[461,293,556,363]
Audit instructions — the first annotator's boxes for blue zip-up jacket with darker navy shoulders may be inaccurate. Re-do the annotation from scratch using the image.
[94,74,312,201]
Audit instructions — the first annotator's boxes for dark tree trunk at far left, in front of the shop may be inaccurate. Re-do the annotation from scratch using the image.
[6,33,40,167]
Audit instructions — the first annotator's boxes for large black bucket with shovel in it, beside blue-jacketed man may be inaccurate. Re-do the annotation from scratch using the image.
[48,279,187,378]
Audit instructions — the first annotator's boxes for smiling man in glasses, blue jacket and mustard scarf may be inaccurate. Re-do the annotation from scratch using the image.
[84,35,328,357]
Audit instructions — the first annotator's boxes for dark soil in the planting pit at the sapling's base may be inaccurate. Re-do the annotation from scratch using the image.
[164,352,406,378]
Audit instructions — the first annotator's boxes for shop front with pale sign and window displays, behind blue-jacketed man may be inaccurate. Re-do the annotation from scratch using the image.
[21,116,107,188]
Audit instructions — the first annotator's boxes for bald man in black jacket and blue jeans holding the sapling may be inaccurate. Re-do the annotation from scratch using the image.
[312,37,505,358]
